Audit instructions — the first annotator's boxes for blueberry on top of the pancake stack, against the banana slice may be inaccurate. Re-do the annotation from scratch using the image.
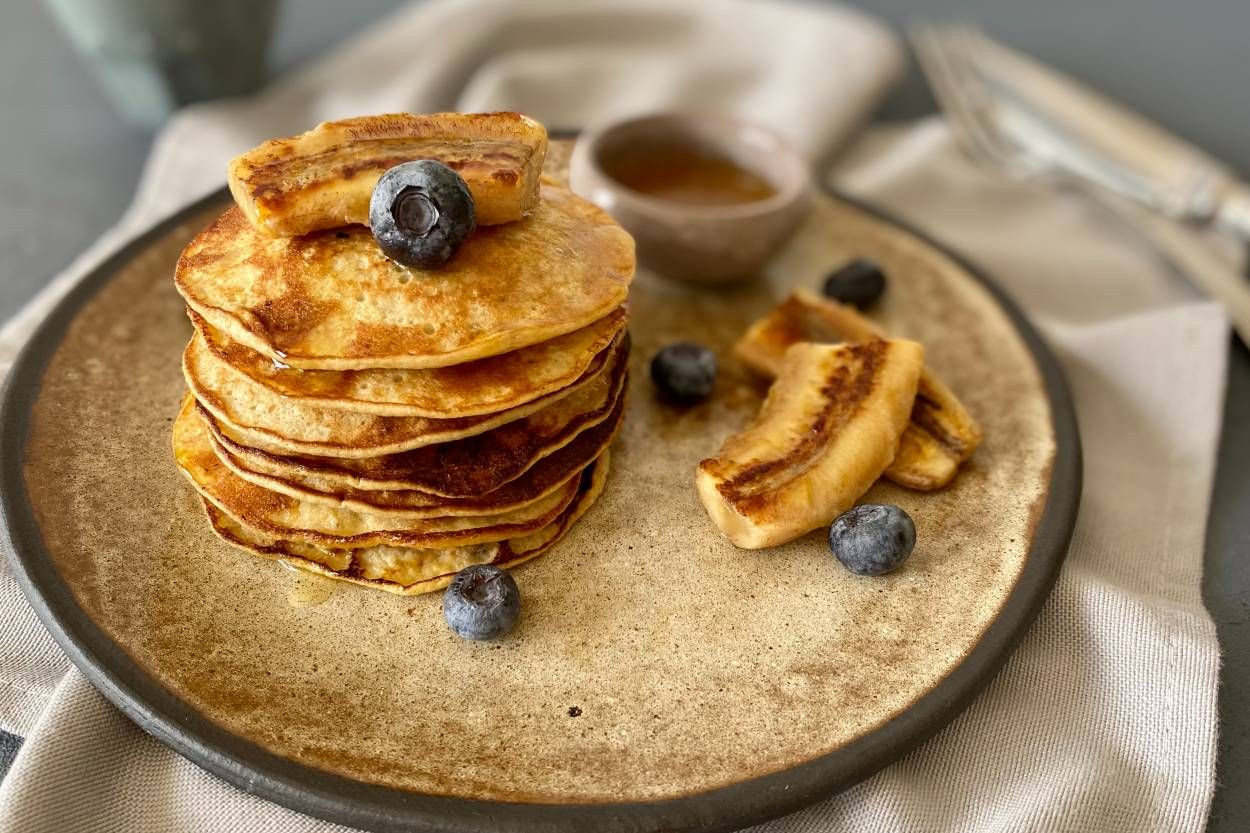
[369,159,475,269]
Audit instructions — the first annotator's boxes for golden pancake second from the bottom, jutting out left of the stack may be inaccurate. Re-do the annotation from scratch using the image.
[174,396,579,549]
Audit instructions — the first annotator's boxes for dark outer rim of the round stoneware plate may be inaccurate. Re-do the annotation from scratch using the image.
[0,184,1083,833]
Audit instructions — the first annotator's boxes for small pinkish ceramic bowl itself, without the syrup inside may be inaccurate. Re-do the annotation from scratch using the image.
[569,113,809,284]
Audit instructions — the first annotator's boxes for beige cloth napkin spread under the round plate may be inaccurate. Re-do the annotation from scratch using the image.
[0,0,1226,833]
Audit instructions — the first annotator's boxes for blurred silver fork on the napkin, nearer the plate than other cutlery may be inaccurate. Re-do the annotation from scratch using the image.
[908,25,1250,345]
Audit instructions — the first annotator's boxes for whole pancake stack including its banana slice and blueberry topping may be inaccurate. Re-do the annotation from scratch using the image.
[174,114,634,594]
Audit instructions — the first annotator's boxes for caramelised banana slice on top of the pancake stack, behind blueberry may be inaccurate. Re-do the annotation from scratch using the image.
[228,113,548,236]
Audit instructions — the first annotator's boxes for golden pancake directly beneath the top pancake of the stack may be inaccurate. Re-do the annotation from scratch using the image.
[189,306,628,419]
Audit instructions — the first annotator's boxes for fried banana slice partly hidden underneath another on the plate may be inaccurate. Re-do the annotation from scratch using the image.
[734,289,981,492]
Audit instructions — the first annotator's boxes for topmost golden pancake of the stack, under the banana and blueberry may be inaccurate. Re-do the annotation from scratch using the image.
[174,185,634,370]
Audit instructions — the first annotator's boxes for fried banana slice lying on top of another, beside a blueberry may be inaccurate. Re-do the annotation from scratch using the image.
[695,339,924,549]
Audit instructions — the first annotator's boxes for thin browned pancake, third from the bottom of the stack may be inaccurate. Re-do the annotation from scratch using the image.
[210,380,625,518]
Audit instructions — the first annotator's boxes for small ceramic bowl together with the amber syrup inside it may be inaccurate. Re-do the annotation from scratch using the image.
[570,113,809,284]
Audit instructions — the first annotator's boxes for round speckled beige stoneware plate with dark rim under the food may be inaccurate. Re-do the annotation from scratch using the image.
[0,152,1080,830]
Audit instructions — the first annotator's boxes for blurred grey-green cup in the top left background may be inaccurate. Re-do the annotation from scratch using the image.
[45,0,278,129]
